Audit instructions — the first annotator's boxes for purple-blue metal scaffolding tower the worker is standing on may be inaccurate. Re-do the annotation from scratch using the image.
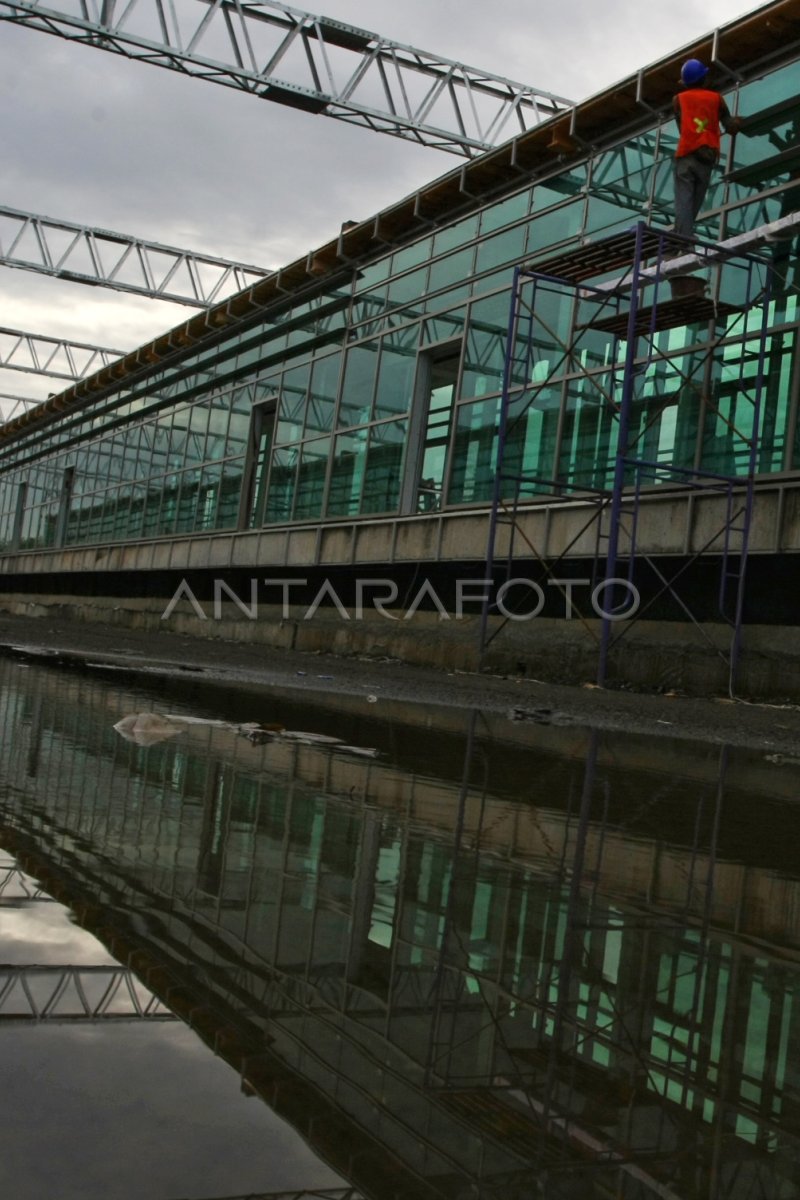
[480,218,777,695]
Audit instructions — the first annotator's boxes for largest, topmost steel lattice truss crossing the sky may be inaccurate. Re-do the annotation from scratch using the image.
[0,0,571,158]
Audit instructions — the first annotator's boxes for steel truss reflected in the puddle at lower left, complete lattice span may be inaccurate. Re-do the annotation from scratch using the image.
[0,965,175,1025]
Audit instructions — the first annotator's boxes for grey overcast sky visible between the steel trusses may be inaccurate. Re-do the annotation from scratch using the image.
[0,0,754,412]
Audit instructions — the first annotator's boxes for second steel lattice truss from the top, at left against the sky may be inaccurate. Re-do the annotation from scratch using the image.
[0,202,271,308]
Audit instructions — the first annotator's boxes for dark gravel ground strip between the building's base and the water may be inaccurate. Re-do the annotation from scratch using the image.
[0,617,800,764]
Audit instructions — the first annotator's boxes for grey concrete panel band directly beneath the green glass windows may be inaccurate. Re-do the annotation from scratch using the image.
[0,474,800,576]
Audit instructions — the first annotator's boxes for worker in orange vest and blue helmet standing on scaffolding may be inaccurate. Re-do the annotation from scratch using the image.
[673,59,741,238]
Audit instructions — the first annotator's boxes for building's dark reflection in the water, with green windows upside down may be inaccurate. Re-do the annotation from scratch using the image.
[0,665,800,1200]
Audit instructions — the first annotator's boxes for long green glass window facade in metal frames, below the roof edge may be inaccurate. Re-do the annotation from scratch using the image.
[0,56,800,551]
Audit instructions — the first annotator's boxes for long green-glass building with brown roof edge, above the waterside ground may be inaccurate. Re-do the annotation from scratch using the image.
[0,7,800,696]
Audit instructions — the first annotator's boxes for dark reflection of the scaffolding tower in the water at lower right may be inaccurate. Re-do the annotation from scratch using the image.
[427,731,796,1200]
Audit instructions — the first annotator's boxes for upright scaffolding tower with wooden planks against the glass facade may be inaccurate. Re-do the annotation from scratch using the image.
[481,218,794,686]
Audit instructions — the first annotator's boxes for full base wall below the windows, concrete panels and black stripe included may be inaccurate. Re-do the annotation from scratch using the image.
[0,479,800,700]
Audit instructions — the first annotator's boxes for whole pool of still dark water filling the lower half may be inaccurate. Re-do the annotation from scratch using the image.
[0,661,800,1200]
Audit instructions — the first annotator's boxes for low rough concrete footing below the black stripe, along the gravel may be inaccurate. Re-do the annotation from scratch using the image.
[0,594,800,701]
